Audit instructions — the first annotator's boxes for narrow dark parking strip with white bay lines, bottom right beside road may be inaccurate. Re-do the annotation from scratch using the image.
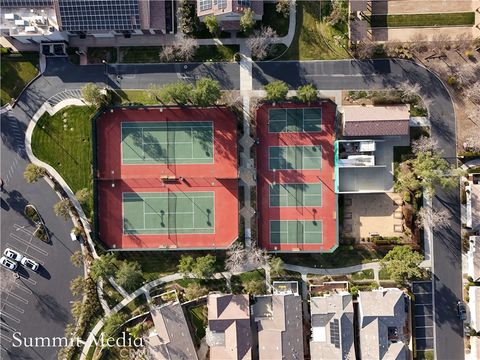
[413,281,435,351]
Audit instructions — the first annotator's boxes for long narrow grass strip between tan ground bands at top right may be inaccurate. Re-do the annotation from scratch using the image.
[370,12,475,27]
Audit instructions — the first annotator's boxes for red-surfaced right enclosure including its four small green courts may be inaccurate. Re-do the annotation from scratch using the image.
[257,101,338,252]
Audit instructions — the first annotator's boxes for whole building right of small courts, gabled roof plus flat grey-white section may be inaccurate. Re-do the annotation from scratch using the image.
[335,105,410,194]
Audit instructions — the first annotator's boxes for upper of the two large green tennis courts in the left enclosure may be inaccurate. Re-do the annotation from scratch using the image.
[122,121,213,164]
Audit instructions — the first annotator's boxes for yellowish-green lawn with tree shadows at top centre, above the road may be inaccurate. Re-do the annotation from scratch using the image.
[281,1,351,60]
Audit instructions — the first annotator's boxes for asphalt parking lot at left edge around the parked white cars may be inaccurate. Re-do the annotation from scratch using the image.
[0,102,83,360]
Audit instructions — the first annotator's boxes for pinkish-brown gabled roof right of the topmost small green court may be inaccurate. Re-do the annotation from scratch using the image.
[343,105,410,136]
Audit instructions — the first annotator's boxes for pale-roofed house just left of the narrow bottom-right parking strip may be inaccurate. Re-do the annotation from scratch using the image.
[358,288,408,360]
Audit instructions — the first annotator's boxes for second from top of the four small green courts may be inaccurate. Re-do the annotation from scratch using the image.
[268,145,322,170]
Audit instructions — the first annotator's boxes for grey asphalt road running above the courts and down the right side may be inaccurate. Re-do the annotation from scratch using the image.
[2,59,464,360]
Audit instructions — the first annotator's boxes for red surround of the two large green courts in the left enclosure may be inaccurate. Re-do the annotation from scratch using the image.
[95,108,238,249]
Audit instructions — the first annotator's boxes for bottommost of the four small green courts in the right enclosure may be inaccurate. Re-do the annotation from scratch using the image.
[270,220,323,244]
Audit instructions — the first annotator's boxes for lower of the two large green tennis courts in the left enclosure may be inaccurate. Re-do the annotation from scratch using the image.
[122,192,215,235]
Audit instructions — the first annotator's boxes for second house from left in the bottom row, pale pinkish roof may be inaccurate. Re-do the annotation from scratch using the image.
[206,294,252,360]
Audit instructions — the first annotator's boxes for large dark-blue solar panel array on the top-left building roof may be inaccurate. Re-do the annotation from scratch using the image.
[58,0,141,31]
